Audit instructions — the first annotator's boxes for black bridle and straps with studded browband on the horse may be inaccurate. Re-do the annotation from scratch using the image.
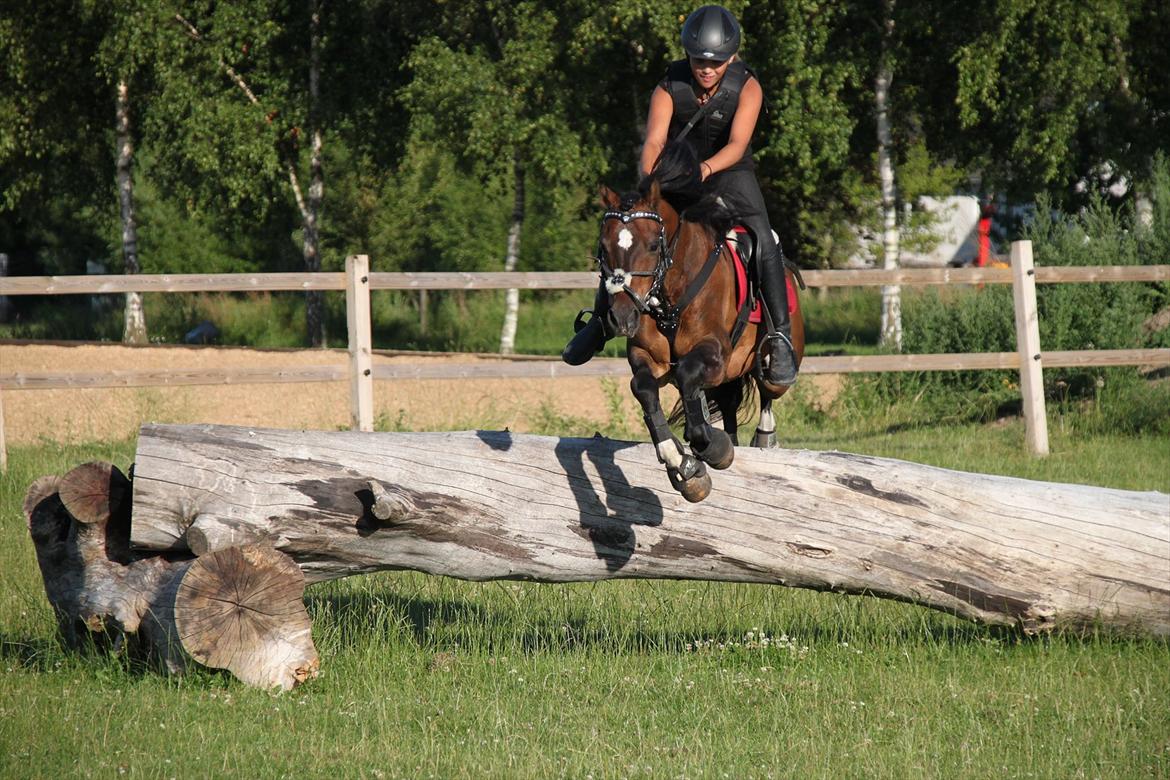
[597,204,723,341]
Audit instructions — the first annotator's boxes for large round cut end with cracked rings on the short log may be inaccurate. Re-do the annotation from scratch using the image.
[174,544,319,690]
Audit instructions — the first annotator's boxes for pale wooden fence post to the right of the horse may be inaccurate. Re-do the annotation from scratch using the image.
[1012,241,1048,455]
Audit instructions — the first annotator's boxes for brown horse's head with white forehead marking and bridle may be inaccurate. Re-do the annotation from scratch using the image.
[598,180,679,337]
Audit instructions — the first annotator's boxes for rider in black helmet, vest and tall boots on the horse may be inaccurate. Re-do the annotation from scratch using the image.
[560,6,797,386]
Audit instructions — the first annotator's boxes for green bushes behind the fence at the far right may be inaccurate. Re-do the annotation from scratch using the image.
[870,160,1170,426]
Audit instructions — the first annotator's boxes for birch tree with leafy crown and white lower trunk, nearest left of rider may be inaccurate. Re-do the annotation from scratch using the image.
[404,1,600,354]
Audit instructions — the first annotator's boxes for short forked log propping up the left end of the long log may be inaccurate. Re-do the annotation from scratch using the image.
[25,463,318,690]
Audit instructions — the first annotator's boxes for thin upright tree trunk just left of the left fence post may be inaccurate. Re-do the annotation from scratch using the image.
[302,0,325,346]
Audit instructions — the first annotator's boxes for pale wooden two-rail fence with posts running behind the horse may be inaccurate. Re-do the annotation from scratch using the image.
[0,241,1170,468]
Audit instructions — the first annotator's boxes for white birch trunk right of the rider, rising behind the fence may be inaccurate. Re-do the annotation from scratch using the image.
[874,0,902,352]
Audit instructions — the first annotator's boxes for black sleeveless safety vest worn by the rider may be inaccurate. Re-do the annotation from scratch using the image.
[660,60,755,171]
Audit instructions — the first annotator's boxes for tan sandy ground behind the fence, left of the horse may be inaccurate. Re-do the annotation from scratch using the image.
[0,343,831,447]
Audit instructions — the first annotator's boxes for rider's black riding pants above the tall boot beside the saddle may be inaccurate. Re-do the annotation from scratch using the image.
[704,170,789,329]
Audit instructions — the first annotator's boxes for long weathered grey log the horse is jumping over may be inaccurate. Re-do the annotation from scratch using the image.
[131,426,1170,636]
